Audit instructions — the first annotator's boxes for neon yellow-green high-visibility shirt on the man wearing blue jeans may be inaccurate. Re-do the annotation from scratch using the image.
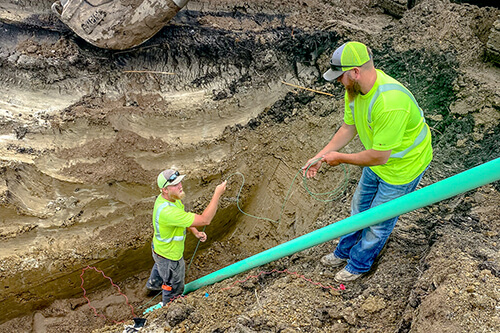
[344,69,432,185]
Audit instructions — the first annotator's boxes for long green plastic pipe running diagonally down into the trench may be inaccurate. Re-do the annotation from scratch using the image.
[184,158,500,294]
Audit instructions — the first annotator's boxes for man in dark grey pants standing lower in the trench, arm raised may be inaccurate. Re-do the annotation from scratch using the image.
[146,169,226,305]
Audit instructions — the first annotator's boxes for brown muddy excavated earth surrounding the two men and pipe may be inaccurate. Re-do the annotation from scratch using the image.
[0,0,500,333]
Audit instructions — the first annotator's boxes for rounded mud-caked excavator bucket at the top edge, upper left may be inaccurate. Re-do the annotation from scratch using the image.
[52,0,189,50]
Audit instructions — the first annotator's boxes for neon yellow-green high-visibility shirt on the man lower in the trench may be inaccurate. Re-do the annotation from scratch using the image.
[153,195,195,260]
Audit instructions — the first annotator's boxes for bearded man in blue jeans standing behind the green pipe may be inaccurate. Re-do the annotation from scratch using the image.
[303,42,432,282]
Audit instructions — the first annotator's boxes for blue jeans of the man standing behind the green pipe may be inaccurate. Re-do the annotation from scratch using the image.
[334,167,425,274]
